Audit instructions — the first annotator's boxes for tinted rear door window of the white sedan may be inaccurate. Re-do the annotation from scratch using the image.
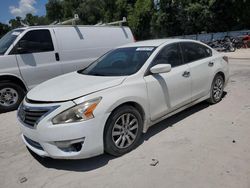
[181,42,212,63]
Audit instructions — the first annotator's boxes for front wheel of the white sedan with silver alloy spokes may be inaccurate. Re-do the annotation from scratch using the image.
[104,105,143,156]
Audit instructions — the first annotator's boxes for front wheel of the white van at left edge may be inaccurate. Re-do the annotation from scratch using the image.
[0,82,25,113]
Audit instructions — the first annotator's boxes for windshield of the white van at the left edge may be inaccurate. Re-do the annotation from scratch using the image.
[0,29,23,55]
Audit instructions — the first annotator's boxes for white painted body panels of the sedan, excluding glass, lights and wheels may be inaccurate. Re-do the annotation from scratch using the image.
[18,39,229,159]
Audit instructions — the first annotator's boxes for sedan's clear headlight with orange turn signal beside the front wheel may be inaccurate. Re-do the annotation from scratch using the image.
[52,97,102,124]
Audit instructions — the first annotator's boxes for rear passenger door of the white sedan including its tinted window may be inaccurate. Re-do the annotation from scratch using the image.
[181,42,215,101]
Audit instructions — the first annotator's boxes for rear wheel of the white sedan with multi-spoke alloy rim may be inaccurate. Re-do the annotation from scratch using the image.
[208,74,225,104]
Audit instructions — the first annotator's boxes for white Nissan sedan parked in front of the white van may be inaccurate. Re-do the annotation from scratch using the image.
[18,39,229,159]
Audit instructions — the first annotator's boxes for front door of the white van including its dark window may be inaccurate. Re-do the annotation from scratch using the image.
[12,29,62,88]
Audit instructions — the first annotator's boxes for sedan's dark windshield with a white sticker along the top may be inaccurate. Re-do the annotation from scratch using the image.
[79,47,155,76]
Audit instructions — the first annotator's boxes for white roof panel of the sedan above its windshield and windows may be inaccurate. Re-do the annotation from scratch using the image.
[119,39,199,48]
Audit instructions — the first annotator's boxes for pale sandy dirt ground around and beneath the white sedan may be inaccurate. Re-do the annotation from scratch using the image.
[0,51,250,188]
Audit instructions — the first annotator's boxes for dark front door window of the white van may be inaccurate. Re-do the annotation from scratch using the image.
[18,30,54,53]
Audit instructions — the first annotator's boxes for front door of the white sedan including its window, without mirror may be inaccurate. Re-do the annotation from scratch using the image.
[144,43,191,121]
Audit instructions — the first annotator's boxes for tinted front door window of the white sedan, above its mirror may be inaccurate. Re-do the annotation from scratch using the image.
[153,43,182,67]
